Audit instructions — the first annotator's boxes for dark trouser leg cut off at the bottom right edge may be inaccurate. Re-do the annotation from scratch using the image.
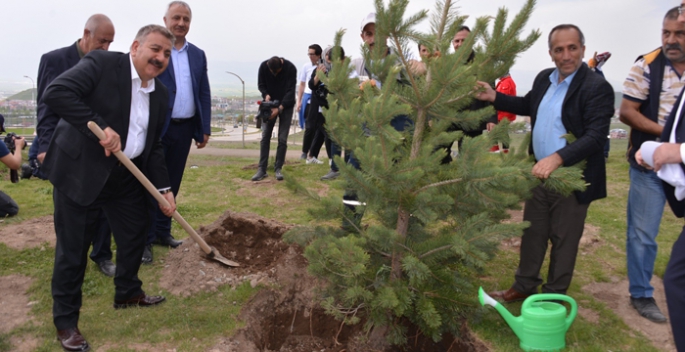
[664,227,685,351]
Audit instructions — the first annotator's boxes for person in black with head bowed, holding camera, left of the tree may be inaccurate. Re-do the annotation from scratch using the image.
[252,56,297,181]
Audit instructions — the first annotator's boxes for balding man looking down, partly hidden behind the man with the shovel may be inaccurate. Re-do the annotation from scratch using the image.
[29,14,116,277]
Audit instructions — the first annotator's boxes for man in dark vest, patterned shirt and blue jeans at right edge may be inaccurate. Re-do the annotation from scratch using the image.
[620,7,685,323]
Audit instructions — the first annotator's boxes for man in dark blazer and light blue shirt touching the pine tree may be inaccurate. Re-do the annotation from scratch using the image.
[477,24,614,302]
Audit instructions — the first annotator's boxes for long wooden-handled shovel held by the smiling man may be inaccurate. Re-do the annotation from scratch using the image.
[88,121,240,266]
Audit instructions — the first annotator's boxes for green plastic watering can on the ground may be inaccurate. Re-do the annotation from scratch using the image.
[478,287,578,351]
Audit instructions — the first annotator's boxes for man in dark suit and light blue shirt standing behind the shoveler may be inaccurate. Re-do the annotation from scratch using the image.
[147,1,212,264]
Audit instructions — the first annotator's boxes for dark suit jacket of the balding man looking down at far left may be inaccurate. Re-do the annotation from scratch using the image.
[33,42,81,153]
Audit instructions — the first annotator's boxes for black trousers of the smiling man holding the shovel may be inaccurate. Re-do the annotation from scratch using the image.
[52,165,149,330]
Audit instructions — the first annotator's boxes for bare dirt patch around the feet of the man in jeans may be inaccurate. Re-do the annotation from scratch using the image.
[583,276,676,352]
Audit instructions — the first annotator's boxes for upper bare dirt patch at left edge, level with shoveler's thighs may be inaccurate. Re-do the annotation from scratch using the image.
[0,215,55,250]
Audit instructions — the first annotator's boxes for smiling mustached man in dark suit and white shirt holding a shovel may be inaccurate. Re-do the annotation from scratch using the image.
[39,25,176,351]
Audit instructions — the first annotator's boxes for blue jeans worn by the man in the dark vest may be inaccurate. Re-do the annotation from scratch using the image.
[626,166,666,298]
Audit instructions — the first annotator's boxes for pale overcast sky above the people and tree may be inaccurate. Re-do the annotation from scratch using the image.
[0,0,680,96]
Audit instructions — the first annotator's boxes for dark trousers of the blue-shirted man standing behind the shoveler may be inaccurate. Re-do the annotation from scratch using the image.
[147,117,198,244]
